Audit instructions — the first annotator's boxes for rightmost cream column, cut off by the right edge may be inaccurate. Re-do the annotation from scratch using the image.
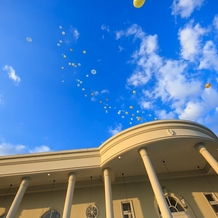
[195,143,218,174]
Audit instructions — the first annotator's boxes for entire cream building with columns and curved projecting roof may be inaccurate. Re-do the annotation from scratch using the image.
[0,120,218,218]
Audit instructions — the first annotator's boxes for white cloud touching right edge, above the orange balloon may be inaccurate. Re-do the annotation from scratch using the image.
[199,41,218,71]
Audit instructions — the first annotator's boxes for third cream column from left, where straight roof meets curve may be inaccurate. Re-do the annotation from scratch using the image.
[103,169,114,218]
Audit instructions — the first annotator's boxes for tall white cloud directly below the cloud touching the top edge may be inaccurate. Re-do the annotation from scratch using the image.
[179,23,207,62]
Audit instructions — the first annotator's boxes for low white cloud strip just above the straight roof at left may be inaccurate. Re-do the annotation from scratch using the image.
[0,142,51,156]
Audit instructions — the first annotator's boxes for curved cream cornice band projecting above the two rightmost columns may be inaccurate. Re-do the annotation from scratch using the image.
[100,120,218,167]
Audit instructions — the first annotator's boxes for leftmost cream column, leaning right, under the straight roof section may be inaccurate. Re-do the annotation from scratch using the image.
[6,178,29,218]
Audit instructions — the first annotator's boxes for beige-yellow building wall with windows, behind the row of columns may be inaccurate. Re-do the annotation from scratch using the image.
[0,176,218,218]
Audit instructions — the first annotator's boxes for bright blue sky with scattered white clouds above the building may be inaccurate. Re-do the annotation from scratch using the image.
[0,0,218,155]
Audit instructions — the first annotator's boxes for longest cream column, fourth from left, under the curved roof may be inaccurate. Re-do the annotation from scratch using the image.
[139,148,172,218]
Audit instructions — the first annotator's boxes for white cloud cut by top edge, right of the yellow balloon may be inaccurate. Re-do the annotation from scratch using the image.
[172,0,204,18]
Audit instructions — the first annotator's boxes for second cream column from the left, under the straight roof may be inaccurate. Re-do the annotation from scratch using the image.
[62,173,76,218]
